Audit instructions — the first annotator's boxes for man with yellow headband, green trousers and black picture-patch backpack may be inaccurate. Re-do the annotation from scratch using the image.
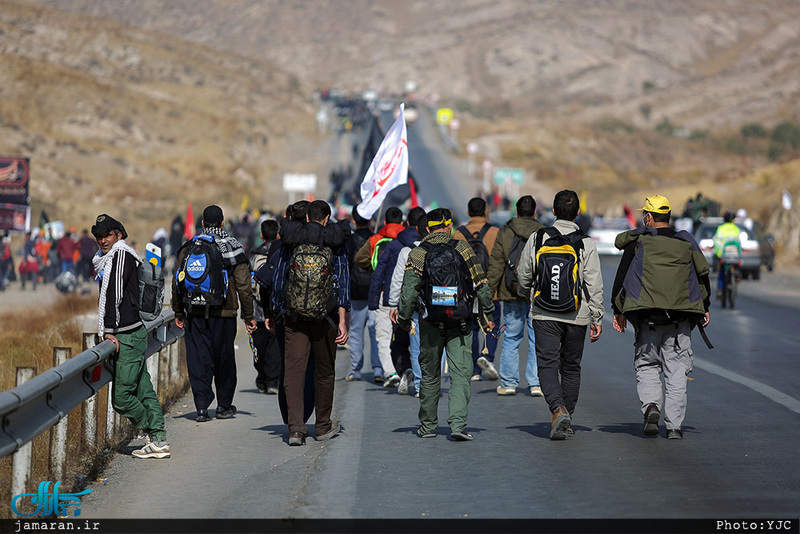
[397,208,494,441]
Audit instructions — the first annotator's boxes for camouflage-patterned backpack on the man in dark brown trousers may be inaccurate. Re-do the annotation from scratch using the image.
[285,243,336,321]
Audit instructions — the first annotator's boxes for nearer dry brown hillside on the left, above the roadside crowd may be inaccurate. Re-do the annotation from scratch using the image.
[0,1,315,239]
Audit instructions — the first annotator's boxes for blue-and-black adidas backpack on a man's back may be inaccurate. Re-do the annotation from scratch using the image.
[175,234,228,314]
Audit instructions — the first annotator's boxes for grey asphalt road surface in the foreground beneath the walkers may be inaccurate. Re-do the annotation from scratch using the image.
[81,110,800,518]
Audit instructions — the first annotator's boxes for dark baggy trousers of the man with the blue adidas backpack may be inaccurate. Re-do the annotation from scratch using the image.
[184,316,236,410]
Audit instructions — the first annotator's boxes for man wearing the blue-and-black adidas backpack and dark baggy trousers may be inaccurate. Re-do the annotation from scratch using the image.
[172,205,256,423]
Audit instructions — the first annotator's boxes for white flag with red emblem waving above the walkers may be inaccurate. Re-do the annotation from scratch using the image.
[356,104,408,219]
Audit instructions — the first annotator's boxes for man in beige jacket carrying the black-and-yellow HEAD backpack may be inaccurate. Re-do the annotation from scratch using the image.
[517,190,603,440]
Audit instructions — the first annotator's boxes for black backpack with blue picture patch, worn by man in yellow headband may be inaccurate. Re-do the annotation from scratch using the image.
[419,239,475,326]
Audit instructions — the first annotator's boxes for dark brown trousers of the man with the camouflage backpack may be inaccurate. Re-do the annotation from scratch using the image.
[283,318,337,436]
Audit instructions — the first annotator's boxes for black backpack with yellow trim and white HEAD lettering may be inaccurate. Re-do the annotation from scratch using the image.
[532,228,587,313]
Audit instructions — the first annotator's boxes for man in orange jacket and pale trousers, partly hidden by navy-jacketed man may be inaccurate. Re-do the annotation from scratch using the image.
[354,206,406,386]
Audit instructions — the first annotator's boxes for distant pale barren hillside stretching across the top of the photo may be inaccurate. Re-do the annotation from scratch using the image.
[25,0,800,128]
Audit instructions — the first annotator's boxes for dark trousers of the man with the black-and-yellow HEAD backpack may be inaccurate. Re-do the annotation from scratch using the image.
[533,320,587,414]
